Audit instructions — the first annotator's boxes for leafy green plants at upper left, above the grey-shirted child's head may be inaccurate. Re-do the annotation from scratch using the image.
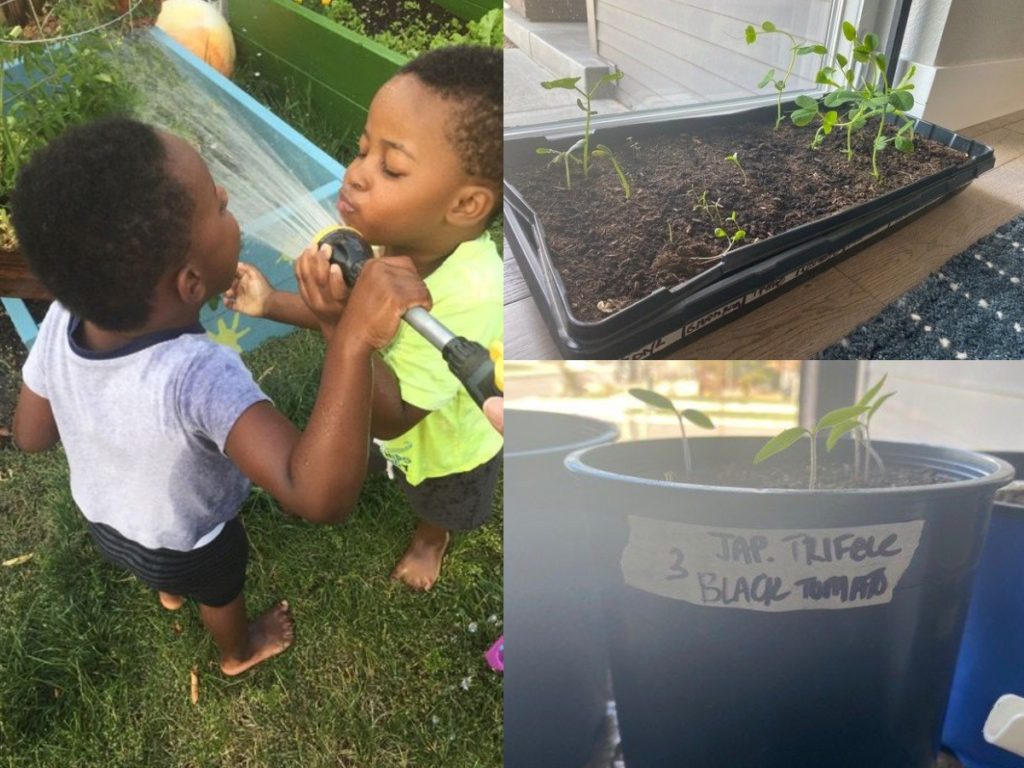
[0,27,136,246]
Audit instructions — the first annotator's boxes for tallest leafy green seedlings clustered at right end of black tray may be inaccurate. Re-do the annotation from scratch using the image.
[746,22,916,178]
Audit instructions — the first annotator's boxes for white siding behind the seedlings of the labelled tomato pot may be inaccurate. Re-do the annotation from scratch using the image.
[861,360,1024,451]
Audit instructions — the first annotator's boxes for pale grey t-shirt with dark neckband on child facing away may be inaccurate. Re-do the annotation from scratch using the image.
[23,301,267,551]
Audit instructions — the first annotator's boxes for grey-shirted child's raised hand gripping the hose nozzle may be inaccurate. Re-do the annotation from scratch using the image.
[338,256,431,349]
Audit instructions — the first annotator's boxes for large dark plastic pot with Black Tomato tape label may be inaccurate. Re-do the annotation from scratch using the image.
[566,437,1013,768]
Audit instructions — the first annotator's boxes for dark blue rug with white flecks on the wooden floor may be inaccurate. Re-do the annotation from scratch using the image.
[817,215,1024,360]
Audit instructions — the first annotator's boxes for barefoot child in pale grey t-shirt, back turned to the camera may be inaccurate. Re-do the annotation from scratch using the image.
[12,118,430,675]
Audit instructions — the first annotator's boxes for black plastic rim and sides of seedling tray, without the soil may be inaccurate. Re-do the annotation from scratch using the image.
[504,105,995,359]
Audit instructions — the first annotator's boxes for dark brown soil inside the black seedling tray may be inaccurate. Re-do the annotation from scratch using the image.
[506,117,968,322]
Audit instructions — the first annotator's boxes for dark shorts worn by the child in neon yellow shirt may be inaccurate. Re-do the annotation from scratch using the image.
[370,451,502,530]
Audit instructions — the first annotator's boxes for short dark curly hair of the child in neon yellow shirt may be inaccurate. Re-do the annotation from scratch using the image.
[398,45,504,199]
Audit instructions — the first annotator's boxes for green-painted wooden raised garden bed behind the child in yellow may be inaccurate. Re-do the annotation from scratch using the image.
[230,0,501,138]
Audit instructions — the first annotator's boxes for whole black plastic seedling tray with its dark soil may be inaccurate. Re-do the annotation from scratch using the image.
[505,101,994,358]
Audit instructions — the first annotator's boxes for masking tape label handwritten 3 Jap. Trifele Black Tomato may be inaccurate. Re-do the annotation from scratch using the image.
[622,515,925,611]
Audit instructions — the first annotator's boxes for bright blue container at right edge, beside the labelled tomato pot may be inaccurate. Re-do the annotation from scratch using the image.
[942,473,1024,768]
